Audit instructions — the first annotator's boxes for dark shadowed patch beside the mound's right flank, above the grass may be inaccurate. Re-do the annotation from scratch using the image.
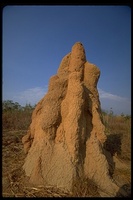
[104,134,122,156]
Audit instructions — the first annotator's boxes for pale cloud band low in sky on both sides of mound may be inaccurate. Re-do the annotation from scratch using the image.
[4,86,131,114]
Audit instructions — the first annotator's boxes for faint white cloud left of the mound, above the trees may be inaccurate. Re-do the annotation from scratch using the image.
[13,86,47,106]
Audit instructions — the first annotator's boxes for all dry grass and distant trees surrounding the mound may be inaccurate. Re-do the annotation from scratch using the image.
[2,100,131,197]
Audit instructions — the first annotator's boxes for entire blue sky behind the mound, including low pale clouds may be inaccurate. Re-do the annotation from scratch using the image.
[2,5,131,114]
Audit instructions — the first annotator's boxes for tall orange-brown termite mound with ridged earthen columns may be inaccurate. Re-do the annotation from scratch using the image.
[22,42,126,197]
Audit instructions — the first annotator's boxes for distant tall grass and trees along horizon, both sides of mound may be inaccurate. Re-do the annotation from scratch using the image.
[2,100,131,134]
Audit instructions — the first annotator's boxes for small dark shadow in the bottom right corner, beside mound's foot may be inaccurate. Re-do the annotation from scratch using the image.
[116,184,131,197]
